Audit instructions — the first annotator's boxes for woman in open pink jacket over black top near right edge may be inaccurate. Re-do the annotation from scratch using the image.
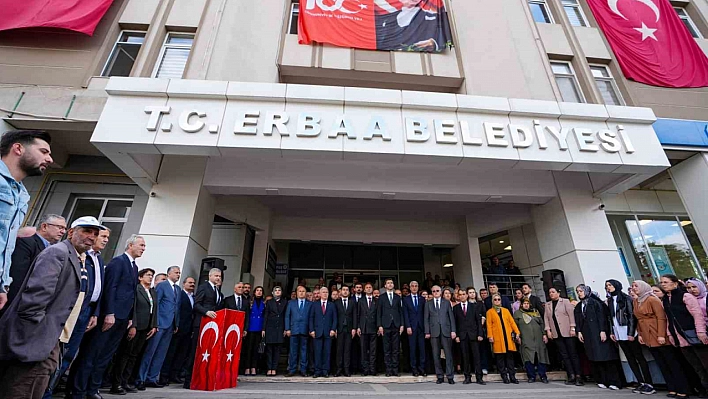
[660,274,708,395]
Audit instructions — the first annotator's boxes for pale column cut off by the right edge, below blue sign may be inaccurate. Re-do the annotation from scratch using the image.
[669,152,708,256]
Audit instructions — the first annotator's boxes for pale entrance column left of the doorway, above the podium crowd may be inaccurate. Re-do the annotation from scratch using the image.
[138,155,214,278]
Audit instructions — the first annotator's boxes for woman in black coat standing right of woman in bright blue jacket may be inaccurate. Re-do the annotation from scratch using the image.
[262,286,288,375]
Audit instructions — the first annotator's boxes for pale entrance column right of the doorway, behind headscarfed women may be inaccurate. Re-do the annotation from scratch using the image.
[531,172,628,292]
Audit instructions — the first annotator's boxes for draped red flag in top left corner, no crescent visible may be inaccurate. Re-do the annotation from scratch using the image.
[0,0,113,36]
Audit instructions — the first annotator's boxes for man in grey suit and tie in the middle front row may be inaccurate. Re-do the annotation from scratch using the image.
[425,285,457,384]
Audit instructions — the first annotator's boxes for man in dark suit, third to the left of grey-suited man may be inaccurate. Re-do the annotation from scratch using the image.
[356,283,378,376]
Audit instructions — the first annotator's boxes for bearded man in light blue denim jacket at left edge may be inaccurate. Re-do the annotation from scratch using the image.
[0,130,54,309]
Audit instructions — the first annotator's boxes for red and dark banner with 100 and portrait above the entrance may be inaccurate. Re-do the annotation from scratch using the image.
[298,0,452,52]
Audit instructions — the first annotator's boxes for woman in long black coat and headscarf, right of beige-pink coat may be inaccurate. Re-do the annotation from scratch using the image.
[575,284,620,390]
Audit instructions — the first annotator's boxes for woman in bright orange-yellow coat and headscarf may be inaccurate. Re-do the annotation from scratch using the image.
[487,294,521,384]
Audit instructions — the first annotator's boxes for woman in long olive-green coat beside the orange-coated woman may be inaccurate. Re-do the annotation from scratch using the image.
[514,298,550,384]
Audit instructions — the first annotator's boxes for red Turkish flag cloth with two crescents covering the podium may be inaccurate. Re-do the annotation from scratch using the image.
[190,309,246,391]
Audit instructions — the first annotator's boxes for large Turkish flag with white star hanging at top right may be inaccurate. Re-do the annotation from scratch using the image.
[588,0,708,87]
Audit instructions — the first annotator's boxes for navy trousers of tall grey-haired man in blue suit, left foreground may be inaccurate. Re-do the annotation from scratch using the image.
[69,317,128,399]
